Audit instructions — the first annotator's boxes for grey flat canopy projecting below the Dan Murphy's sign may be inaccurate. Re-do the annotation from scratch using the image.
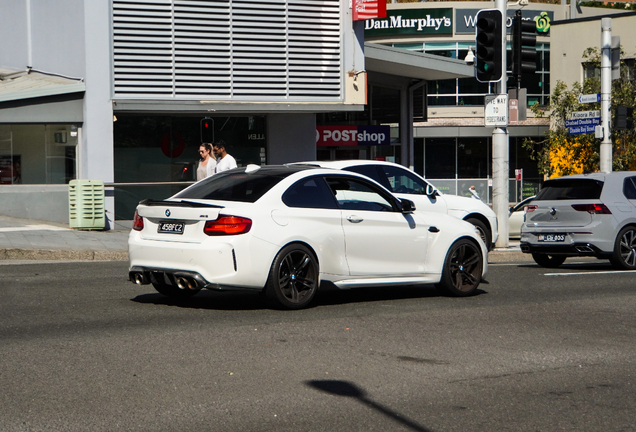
[364,42,474,81]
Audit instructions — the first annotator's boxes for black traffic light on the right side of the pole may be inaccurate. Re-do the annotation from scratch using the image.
[512,10,537,85]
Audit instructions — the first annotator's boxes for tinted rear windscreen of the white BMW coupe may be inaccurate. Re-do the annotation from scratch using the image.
[174,168,299,203]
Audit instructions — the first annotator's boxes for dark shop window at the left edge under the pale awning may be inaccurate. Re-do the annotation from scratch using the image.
[0,124,78,184]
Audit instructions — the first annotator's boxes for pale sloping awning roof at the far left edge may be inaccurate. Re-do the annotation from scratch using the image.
[0,69,86,102]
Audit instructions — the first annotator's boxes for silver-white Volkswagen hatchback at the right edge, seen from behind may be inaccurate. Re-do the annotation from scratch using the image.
[520,171,636,270]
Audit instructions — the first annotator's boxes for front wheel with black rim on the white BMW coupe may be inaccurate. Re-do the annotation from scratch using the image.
[436,239,484,297]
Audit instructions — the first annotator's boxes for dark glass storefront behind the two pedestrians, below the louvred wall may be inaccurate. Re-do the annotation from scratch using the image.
[114,114,267,220]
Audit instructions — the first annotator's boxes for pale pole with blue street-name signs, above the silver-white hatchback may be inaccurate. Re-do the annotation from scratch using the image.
[600,18,612,172]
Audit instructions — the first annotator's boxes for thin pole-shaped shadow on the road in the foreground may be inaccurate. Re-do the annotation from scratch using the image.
[305,380,431,432]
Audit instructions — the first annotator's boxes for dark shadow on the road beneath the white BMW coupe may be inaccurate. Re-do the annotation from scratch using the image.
[131,284,487,311]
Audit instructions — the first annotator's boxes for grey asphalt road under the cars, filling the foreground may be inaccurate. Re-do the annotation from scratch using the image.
[0,261,636,432]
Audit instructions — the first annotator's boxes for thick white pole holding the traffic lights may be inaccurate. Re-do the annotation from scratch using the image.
[492,0,510,248]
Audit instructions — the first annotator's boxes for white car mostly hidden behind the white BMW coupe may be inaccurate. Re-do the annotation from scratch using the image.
[296,160,499,250]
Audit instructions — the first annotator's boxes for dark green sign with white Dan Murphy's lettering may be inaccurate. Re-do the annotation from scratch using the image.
[364,8,453,36]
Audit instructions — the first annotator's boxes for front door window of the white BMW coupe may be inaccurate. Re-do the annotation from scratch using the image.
[326,177,395,212]
